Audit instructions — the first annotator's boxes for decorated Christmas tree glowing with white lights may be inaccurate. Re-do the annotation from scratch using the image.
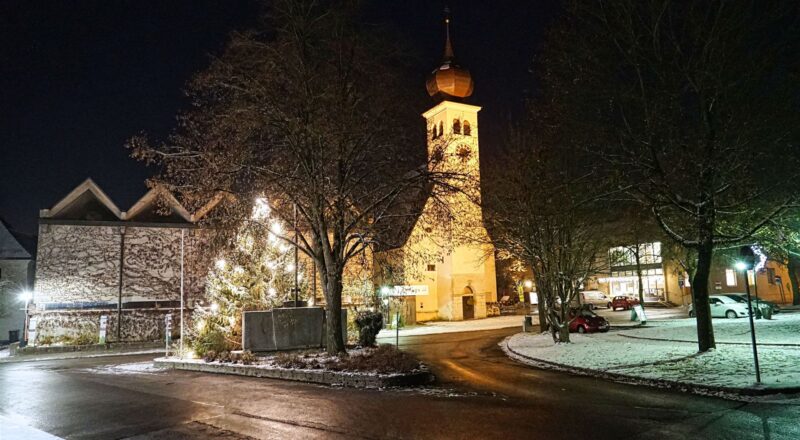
[192,199,310,356]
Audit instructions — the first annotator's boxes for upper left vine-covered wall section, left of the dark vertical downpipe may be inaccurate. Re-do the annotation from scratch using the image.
[34,225,120,303]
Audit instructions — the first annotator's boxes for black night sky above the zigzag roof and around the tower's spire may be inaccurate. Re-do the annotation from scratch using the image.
[0,0,559,232]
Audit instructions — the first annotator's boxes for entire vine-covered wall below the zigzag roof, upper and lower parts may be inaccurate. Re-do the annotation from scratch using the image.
[32,225,211,342]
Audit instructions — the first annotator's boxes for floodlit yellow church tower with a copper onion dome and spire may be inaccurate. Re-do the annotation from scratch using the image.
[406,9,497,321]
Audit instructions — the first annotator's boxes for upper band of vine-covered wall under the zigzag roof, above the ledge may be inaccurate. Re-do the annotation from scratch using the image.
[35,225,209,304]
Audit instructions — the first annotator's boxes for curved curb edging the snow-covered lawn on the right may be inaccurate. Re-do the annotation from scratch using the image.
[500,335,800,400]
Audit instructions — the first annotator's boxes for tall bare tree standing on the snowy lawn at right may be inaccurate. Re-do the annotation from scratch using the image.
[541,0,800,351]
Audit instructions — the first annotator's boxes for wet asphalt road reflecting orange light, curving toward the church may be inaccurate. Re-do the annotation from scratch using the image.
[0,329,800,440]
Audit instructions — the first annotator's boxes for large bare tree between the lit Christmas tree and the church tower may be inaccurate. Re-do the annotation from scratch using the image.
[130,0,457,353]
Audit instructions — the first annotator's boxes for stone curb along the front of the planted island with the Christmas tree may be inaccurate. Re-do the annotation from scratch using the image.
[153,358,435,388]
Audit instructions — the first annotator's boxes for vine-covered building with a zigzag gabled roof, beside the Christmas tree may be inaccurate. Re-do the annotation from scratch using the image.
[31,179,222,342]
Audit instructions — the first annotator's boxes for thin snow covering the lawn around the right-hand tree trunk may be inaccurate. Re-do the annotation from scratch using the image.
[502,314,800,388]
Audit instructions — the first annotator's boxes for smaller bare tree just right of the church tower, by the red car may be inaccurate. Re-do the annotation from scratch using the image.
[485,128,608,342]
